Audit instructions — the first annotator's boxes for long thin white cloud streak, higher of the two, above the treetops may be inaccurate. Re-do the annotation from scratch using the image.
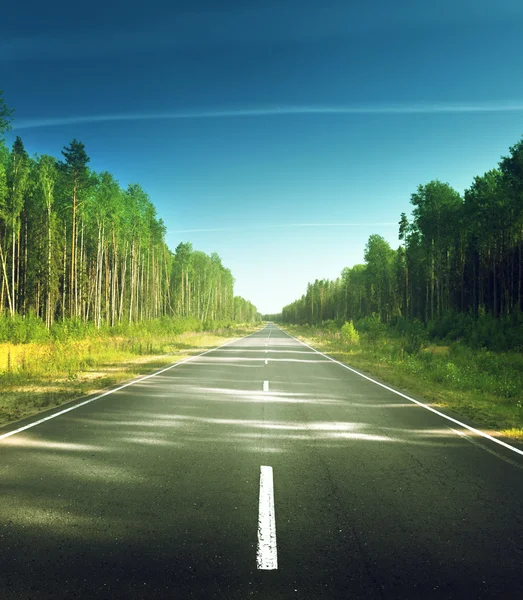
[13,102,523,129]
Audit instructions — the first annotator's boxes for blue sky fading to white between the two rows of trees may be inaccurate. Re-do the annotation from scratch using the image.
[0,0,523,312]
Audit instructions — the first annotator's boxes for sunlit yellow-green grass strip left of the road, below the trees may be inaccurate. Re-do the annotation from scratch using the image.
[0,319,259,426]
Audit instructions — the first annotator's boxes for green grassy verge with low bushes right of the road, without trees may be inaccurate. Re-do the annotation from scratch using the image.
[284,325,523,440]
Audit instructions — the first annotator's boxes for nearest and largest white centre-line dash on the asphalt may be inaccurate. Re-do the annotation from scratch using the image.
[256,466,278,571]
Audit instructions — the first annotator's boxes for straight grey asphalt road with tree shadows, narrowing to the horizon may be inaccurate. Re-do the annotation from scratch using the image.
[0,325,523,600]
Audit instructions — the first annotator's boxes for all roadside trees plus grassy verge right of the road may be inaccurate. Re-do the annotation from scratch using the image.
[266,135,523,439]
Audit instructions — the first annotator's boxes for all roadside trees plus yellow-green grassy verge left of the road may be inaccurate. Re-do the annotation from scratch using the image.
[0,92,260,426]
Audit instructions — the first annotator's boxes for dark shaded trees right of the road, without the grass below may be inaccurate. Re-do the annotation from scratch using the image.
[282,134,523,325]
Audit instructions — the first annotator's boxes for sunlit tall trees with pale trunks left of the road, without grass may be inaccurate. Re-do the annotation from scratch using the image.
[0,92,259,327]
